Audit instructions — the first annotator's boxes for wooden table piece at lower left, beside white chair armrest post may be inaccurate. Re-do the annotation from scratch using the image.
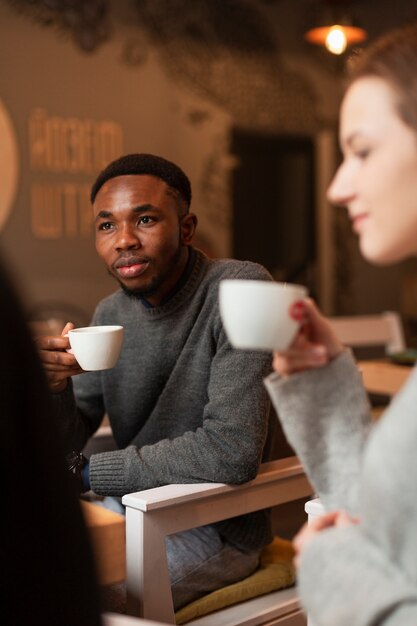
[80,500,126,585]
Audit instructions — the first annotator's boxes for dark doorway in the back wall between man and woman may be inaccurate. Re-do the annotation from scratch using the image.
[232,129,315,294]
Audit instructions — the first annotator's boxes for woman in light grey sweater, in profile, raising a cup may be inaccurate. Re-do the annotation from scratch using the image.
[266,20,417,626]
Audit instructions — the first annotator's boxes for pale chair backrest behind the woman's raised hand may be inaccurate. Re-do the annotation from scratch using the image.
[329,311,405,354]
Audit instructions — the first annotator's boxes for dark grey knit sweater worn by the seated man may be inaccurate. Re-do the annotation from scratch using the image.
[55,251,271,549]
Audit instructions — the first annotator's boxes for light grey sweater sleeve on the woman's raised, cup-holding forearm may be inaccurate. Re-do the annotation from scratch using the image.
[265,350,370,513]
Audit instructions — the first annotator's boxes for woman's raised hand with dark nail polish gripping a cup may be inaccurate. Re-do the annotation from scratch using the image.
[272,298,345,376]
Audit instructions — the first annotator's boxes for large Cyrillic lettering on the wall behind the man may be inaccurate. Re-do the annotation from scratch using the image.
[28,108,123,239]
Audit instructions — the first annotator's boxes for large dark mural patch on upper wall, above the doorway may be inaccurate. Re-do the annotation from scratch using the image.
[132,0,318,134]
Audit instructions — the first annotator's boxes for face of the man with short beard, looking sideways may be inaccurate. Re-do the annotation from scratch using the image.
[93,175,196,305]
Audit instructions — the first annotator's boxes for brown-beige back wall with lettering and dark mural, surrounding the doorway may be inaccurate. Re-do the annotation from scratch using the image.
[0,0,407,326]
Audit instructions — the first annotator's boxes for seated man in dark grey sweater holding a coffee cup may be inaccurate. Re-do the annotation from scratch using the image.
[39,154,271,609]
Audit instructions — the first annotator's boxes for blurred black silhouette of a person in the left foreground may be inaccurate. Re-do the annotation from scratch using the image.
[0,255,101,626]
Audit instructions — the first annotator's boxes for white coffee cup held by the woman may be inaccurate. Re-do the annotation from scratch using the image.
[219,279,308,351]
